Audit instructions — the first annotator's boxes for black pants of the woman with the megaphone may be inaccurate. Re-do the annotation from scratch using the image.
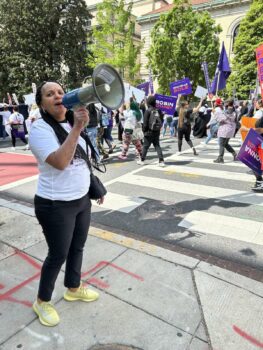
[35,195,91,301]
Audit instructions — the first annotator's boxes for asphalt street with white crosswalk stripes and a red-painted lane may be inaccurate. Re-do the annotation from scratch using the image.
[0,132,263,269]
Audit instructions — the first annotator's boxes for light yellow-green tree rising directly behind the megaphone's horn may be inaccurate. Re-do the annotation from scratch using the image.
[88,0,142,84]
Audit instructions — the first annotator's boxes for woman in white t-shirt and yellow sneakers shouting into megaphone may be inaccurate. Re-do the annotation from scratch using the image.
[29,82,104,326]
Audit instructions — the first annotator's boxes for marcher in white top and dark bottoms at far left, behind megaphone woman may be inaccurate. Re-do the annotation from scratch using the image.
[9,106,28,151]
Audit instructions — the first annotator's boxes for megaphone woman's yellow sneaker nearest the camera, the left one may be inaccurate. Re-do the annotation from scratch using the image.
[33,301,60,327]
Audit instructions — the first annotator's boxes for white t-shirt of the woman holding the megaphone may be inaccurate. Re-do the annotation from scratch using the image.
[29,119,90,201]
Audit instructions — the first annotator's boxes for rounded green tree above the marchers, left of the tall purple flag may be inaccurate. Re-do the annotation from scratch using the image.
[147,0,221,94]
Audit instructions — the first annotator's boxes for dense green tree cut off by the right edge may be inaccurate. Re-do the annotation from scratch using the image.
[227,0,263,99]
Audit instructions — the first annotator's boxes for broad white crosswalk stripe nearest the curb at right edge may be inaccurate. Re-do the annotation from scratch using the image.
[178,210,263,245]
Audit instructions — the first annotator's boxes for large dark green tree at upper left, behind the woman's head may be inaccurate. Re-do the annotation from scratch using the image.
[0,0,93,100]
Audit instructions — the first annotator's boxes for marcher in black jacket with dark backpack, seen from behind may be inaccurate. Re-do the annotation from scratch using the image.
[137,96,165,167]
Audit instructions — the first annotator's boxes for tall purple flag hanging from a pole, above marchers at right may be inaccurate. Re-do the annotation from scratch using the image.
[211,43,231,94]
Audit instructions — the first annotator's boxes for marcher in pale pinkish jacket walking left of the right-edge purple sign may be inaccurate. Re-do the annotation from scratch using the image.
[214,99,237,163]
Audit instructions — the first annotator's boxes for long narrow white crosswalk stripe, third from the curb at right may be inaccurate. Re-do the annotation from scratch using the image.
[145,163,254,182]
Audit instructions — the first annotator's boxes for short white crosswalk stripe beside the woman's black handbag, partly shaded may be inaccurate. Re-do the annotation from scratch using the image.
[93,192,146,214]
